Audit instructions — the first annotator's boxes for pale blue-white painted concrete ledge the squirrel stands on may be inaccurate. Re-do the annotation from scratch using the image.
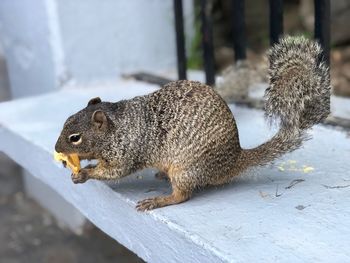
[0,81,350,262]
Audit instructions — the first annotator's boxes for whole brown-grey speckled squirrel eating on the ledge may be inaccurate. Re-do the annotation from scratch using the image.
[55,37,331,211]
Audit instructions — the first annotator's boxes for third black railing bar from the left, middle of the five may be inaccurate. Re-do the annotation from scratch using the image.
[232,0,247,62]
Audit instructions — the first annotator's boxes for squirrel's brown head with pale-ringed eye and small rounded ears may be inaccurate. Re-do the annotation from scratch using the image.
[55,97,113,159]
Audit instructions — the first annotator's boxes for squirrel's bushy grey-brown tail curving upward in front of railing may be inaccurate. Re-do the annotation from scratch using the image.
[242,37,330,166]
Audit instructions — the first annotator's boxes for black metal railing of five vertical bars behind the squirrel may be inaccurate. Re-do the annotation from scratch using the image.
[174,0,330,85]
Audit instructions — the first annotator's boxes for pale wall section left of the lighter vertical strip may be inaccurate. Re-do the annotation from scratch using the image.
[0,0,55,97]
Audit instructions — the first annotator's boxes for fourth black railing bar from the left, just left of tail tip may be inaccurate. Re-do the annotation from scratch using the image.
[270,0,283,46]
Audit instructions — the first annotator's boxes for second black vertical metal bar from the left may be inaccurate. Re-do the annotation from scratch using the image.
[200,0,215,85]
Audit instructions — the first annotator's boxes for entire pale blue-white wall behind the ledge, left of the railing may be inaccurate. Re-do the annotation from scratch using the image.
[0,0,193,97]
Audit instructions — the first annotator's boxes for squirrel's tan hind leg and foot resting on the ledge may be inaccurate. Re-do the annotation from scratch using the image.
[136,187,192,211]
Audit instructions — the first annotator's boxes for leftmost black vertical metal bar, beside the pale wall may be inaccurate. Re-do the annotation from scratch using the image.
[174,0,187,79]
